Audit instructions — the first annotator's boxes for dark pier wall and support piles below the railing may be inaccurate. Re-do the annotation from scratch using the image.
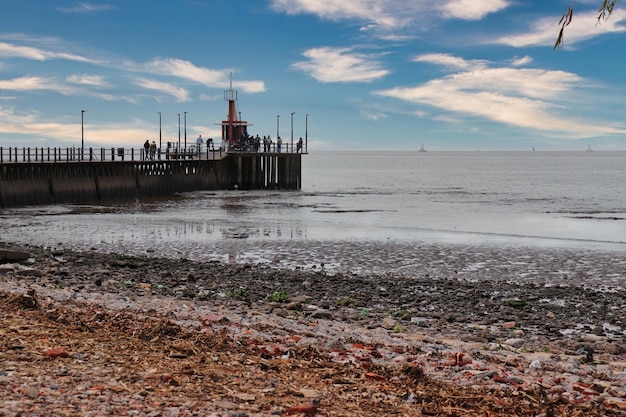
[0,152,302,207]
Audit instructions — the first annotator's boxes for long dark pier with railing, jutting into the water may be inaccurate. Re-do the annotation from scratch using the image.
[0,147,306,207]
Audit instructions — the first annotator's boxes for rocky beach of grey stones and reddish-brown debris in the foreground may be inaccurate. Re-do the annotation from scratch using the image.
[0,243,626,417]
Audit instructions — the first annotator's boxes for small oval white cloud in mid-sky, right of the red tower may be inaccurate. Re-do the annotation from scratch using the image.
[292,47,389,83]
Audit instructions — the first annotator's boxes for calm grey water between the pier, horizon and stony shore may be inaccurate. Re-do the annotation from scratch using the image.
[0,152,626,281]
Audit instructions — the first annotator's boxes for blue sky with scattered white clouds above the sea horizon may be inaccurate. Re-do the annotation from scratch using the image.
[0,0,626,151]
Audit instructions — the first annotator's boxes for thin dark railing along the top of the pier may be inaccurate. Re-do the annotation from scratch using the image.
[0,143,306,163]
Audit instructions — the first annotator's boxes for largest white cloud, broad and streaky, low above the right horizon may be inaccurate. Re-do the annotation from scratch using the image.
[375,55,624,137]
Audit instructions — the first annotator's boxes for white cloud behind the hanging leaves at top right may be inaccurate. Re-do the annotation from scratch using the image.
[493,10,626,48]
